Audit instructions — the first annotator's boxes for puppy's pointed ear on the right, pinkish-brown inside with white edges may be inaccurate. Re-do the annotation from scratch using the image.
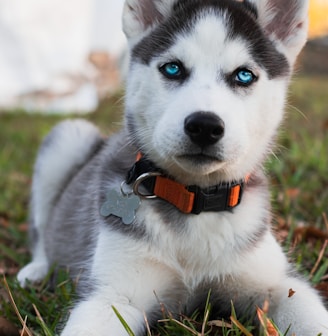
[253,0,309,64]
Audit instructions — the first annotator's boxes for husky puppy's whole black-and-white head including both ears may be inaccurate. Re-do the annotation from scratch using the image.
[123,0,307,186]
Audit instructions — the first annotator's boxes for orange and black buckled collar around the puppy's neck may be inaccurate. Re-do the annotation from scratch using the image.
[126,155,248,214]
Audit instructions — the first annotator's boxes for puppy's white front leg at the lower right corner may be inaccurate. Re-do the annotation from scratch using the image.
[241,234,328,336]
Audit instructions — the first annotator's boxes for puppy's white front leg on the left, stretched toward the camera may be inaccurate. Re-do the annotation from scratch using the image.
[61,232,187,336]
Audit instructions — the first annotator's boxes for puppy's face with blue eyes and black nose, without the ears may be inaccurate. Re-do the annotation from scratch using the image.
[126,3,289,185]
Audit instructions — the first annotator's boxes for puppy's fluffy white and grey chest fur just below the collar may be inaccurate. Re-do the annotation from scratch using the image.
[101,180,267,285]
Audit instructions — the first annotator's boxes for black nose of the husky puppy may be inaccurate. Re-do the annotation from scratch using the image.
[184,112,224,148]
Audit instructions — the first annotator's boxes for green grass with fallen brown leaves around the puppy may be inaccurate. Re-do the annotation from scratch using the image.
[0,77,328,336]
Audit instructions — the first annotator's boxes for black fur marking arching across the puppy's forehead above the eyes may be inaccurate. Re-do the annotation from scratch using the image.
[132,0,290,78]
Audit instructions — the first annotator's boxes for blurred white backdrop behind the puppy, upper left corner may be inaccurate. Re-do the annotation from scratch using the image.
[0,0,125,113]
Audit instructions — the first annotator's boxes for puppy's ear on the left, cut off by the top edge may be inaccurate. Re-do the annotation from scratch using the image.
[123,0,176,43]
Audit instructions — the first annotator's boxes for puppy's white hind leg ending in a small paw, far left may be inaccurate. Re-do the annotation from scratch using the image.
[17,120,102,286]
